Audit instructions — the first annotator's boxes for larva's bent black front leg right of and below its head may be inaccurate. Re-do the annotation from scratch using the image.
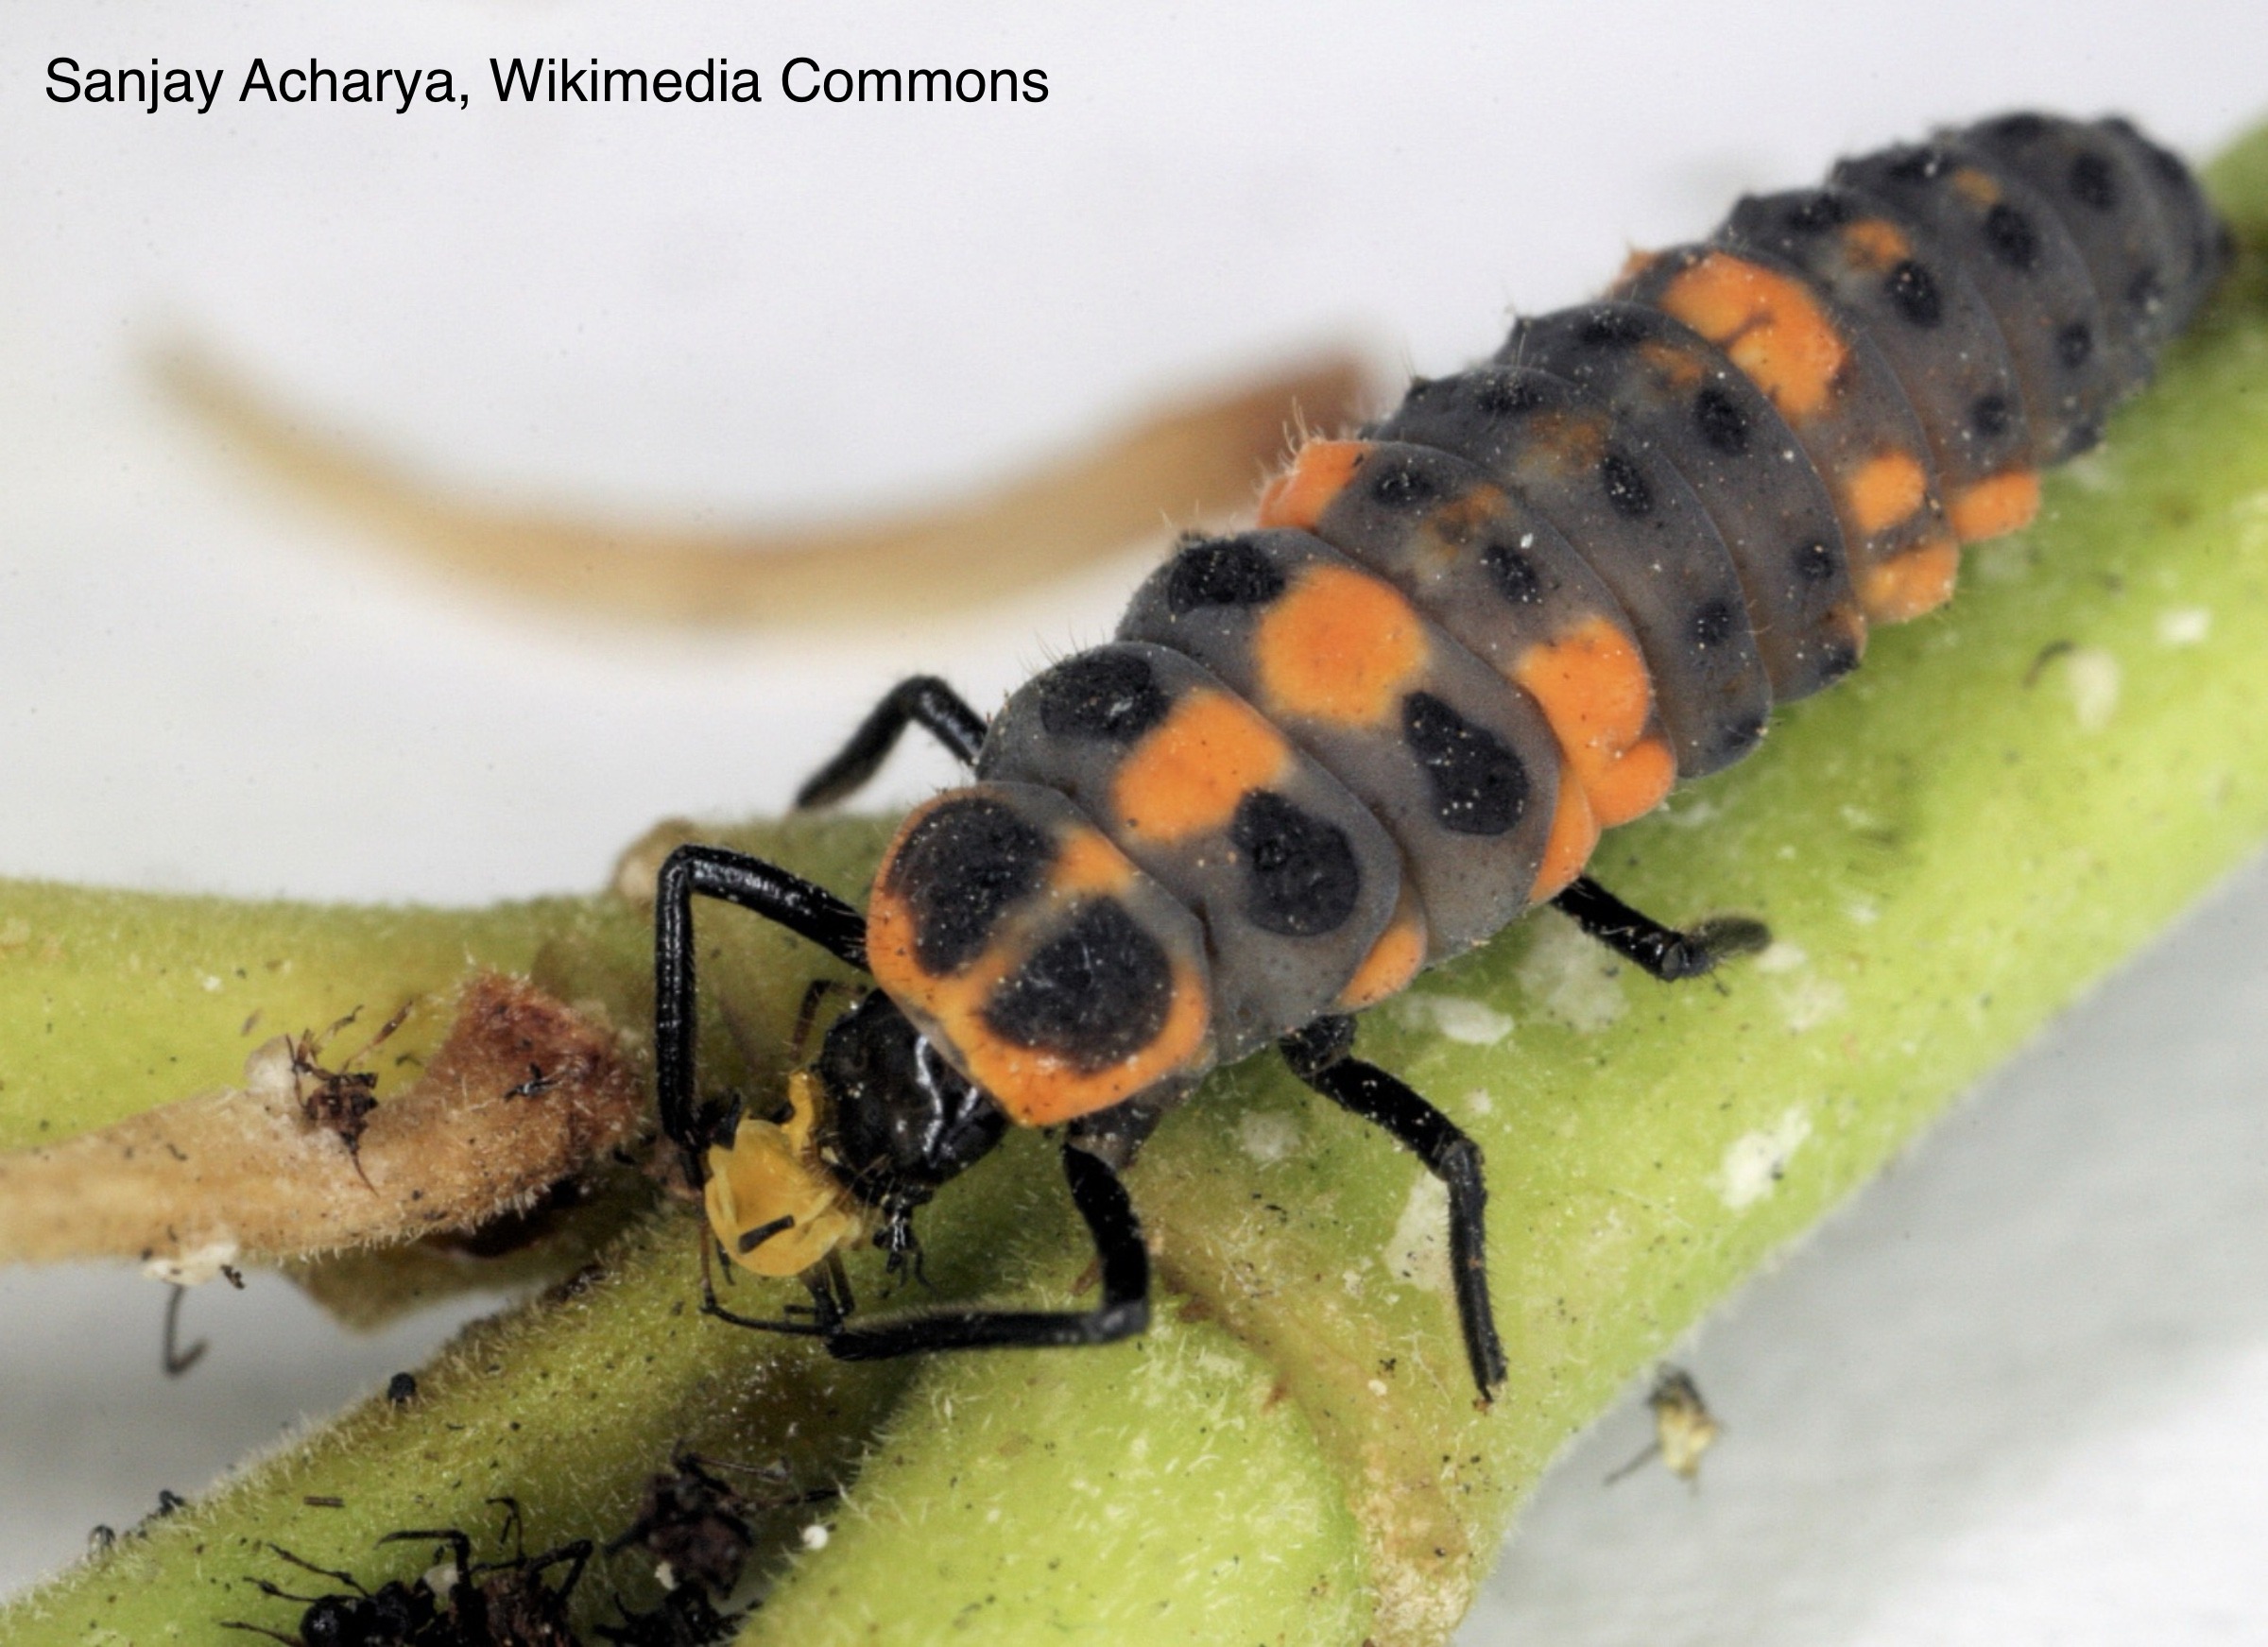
[826,1141,1150,1361]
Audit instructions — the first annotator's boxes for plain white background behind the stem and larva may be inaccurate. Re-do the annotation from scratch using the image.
[0,0,2268,1645]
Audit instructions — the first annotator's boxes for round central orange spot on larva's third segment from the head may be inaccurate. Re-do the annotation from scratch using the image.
[1252,565,1431,726]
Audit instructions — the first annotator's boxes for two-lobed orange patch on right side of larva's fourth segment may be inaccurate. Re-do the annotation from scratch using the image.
[1506,617,1676,826]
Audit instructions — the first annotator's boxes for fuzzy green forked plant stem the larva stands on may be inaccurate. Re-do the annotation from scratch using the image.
[0,122,2268,1647]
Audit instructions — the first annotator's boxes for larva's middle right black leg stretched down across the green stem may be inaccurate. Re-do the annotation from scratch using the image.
[1281,1019,1506,1399]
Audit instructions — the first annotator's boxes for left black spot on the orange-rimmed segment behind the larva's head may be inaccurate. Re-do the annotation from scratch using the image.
[885,797,1055,978]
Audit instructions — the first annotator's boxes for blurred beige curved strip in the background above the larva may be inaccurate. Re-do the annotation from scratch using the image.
[152,345,1374,628]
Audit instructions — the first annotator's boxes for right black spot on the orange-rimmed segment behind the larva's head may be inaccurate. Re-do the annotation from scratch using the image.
[985,899,1173,1075]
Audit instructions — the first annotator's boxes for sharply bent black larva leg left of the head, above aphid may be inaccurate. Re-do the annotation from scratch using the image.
[653,847,867,1182]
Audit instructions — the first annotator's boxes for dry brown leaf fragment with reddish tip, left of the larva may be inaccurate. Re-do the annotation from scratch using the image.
[0,973,646,1281]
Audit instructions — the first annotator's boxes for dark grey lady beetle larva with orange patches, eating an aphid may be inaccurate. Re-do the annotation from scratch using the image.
[656,113,2229,1398]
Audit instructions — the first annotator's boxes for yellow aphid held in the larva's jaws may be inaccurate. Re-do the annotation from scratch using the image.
[703,1071,867,1275]
